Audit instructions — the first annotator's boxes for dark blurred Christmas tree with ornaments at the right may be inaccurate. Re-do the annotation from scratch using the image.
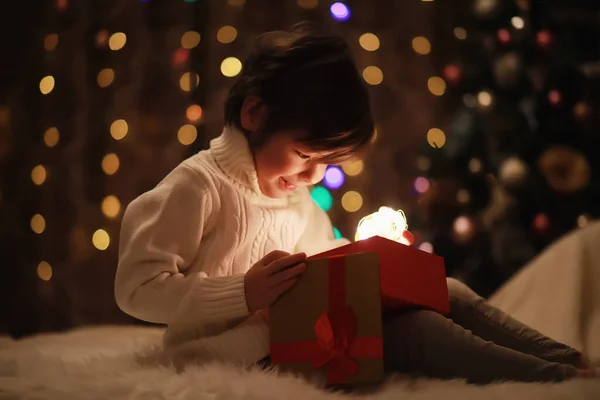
[409,0,600,295]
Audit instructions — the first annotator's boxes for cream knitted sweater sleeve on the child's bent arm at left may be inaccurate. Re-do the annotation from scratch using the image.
[115,164,249,324]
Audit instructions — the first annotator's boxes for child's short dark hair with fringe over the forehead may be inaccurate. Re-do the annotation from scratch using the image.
[225,25,374,158]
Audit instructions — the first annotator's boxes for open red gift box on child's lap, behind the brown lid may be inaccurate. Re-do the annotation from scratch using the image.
[309,236,450,315]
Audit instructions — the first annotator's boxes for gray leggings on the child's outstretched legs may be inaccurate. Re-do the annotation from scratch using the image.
[383,278,581,383]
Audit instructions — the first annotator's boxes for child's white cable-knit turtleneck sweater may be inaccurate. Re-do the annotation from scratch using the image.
[115,127,348,365]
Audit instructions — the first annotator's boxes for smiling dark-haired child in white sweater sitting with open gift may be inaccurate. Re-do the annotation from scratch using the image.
[115,25,591,382]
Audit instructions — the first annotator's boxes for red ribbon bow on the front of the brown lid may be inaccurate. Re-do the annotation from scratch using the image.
[312,306,358,376]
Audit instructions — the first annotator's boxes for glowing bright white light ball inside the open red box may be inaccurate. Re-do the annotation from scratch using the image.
[349,206,410,245]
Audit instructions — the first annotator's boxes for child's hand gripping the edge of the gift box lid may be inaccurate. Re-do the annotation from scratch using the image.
[244,250,306,313]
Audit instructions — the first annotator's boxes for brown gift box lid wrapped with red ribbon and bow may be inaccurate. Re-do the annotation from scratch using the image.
[269,253,384,385]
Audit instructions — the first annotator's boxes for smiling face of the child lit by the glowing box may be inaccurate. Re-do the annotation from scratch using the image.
[254,131,327,198]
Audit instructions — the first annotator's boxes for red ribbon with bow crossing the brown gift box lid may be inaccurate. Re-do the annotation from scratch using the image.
[271,257,383,384]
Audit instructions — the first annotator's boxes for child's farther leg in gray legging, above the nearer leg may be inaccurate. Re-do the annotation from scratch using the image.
[447,278,588,368]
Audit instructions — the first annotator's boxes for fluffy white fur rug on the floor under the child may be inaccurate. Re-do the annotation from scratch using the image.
[0,326,600,400]
